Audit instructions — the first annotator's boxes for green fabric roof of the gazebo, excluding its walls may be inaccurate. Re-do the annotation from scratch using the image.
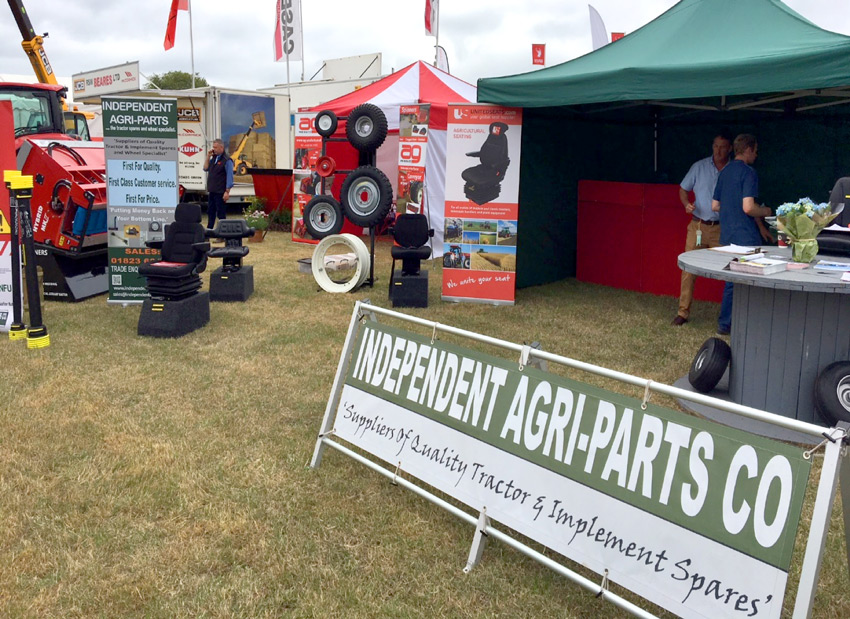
[478,0,850,108]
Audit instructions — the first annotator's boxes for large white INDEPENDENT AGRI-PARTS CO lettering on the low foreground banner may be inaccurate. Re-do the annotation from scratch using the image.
[350,329,794,556]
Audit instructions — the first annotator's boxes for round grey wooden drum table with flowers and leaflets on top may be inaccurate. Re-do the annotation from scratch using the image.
[678,247,850,425]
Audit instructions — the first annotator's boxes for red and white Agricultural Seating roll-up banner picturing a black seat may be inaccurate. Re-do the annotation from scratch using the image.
[442,104,522,305]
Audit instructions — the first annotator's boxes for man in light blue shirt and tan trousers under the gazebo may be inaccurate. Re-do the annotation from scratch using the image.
[672,134,732,327]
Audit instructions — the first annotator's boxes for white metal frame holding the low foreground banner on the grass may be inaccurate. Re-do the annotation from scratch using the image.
[309,301,850,619]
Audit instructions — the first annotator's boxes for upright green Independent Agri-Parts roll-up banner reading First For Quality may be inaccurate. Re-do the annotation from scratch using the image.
[102,97,178,303]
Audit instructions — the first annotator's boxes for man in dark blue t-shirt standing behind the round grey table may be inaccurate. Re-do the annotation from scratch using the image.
[711,133,772,335]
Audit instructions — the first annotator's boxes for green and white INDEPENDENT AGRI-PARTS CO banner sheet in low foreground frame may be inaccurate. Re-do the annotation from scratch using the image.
[333,321,810,619]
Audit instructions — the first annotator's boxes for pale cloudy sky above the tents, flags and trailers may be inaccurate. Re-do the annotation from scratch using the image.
[0,0,850,94]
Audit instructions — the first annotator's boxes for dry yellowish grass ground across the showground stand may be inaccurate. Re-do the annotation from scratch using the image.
[0,233,850,619]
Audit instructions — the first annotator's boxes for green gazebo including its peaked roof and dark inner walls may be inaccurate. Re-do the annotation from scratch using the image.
[478,0,850,287]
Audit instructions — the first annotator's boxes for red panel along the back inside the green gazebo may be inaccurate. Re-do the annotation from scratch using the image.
[576,181,723,302]
